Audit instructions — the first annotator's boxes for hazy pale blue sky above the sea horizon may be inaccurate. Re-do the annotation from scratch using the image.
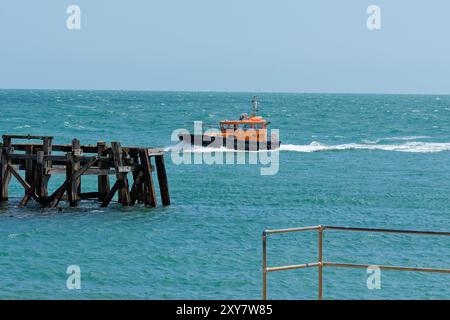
[0,0,450,93]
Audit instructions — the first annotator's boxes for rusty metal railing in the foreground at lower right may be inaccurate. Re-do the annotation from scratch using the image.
[262,225,450,300]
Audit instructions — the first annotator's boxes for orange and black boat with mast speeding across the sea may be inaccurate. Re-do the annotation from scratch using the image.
[178,97,280,151]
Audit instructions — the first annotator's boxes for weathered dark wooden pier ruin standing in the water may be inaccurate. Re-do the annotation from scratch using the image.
[0,135,170,208]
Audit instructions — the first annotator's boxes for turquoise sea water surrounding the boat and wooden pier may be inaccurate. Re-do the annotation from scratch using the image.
[0,90,450,299]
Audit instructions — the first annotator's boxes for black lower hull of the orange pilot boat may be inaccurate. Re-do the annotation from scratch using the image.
[178,134,281,151]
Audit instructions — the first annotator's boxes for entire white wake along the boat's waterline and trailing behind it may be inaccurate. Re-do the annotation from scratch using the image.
[165,139,450,153]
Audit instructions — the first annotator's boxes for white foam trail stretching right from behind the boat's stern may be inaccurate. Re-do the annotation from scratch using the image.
[280,141,450,153]
